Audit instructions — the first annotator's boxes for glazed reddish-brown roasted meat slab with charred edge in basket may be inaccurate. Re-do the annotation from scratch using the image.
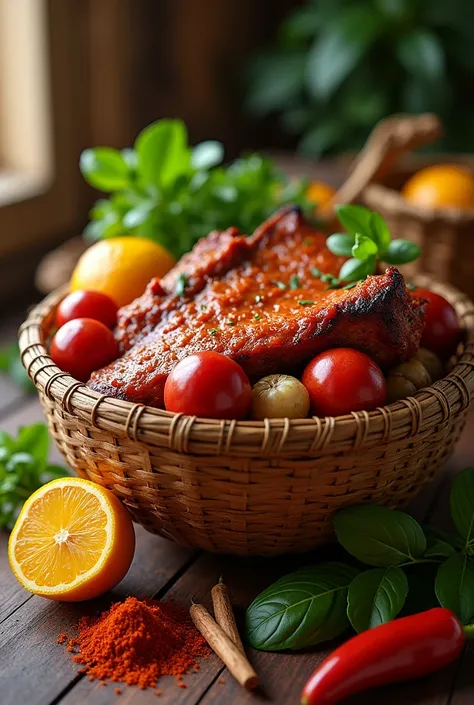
[88,208,424,407]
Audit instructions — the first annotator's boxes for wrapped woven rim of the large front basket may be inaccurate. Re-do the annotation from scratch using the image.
[19,274,474,458]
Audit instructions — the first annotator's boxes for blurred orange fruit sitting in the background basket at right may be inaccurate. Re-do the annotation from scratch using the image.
[402,164,474,210]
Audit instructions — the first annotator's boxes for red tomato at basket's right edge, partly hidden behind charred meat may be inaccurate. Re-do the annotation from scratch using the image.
[415,289,461,360]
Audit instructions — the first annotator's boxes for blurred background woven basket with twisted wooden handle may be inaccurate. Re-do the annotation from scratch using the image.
[333,114,474,298]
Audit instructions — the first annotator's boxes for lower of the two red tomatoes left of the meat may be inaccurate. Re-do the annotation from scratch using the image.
[50,318,119,382]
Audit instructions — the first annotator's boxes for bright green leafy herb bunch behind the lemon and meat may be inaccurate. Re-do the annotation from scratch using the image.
[80,119,314,258]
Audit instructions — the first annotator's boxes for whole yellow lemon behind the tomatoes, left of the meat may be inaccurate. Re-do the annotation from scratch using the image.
[71,236,176,306]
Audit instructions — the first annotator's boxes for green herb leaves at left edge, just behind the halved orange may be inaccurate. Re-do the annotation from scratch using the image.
[0,423,67,529]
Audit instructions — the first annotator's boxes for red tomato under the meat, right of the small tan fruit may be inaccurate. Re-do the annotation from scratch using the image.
[302,348,386,416]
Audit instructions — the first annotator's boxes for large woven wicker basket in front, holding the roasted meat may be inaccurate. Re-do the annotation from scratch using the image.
[20,277,474,555]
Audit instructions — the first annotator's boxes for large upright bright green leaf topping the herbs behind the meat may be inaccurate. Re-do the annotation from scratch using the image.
[135,120,191,189]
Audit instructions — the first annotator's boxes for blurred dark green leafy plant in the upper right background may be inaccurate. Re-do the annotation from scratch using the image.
[247,0,474,155]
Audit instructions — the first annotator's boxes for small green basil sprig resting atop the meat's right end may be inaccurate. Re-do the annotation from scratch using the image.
[326,205,421,283]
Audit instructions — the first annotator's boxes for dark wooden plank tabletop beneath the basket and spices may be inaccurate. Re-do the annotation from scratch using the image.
[0,316,474,705]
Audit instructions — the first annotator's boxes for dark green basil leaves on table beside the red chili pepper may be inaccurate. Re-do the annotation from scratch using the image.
[246,468,474,651]
